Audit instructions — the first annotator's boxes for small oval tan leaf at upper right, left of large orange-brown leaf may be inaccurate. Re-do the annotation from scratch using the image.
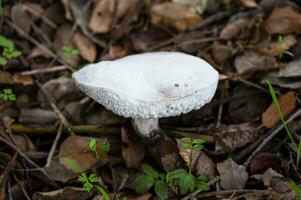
[219,18,249,40]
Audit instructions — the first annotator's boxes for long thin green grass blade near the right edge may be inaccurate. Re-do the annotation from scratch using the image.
[267,81,301,166]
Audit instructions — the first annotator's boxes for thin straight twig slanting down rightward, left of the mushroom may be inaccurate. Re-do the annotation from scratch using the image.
[36,80,75,135]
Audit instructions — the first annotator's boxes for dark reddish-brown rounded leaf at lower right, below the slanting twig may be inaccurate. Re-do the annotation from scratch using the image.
[249,153,281,175]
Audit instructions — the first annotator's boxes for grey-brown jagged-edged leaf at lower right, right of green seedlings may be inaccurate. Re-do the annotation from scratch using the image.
[217,158,249,190]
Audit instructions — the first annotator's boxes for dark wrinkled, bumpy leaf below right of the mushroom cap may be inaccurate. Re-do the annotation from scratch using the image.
[216,123,258,150]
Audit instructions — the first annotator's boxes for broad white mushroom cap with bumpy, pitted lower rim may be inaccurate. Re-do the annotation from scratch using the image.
[72,52,218,118]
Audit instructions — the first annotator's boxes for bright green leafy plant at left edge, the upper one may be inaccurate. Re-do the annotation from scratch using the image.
[0,35,22,66]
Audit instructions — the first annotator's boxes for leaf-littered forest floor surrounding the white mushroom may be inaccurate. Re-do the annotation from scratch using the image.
[0,0,301,200]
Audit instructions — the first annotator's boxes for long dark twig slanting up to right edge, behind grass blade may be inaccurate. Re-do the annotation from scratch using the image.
[244,108,301,166]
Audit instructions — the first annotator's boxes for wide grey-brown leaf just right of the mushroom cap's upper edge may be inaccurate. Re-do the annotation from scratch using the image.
[234,50,279,74]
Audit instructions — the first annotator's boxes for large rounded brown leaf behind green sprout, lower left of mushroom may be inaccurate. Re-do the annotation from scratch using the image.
[59,136,106,171]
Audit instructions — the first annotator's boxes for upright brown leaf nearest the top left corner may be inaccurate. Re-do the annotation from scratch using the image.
[11,3,32,34]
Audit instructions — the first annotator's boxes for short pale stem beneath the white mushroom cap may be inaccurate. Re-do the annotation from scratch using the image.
[132,118,159,137]
